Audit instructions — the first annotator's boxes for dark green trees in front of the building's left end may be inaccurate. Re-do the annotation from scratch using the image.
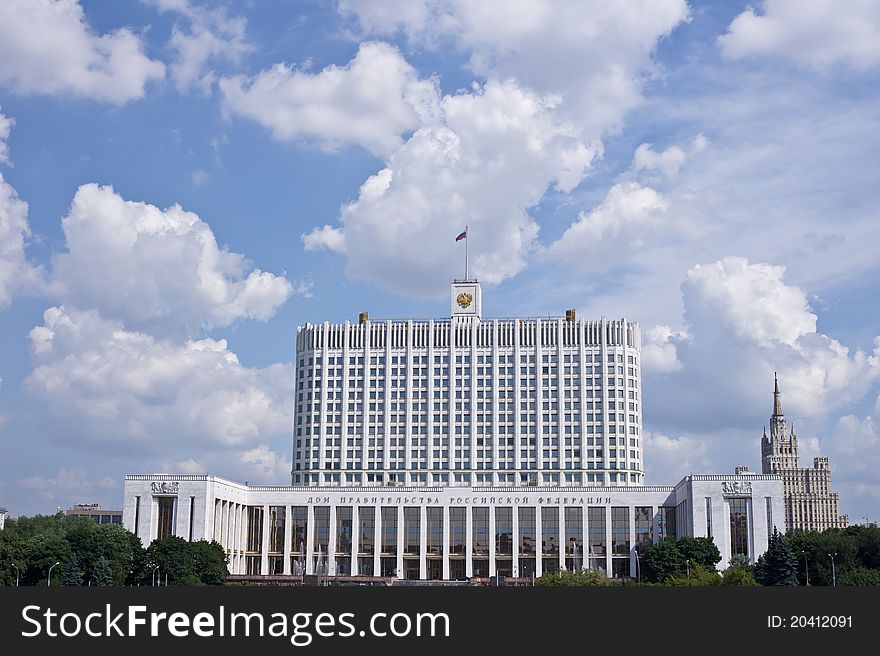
[0,513,228,586]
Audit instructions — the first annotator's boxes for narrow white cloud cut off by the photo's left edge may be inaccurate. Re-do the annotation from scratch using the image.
[0,114,43,309]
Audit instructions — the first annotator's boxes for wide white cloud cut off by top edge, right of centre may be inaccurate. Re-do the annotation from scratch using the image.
[339,0,688,141]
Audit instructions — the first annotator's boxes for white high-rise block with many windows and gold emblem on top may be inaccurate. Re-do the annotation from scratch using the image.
[291,280,644,487]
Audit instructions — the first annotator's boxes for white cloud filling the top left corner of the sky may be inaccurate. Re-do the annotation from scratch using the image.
[0,0,165,105]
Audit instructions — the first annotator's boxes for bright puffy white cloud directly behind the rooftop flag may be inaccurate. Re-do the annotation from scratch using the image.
[303,81,595,296]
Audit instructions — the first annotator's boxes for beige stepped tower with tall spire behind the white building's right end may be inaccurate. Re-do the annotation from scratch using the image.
[761,375,848,531]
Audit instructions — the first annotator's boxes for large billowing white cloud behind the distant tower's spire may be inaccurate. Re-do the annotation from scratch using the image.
[646,257,880,430]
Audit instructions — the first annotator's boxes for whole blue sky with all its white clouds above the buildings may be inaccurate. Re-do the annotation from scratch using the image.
[0,0,880,521]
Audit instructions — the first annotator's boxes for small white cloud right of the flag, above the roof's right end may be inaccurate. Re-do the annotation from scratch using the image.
[548,182,677,271]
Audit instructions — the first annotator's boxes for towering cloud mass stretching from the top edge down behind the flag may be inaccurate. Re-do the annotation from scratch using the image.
[292,0,688,297]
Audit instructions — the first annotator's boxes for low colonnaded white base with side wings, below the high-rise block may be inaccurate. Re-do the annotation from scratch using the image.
[123,473,783,580]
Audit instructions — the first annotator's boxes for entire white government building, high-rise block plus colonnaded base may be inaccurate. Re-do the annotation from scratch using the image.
[123,280,784,580]
